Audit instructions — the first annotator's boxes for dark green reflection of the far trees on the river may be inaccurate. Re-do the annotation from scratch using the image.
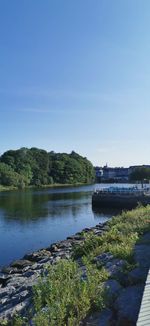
[0,191,91,223]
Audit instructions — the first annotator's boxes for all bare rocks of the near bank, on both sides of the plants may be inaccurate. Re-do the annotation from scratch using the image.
[0,223,150,326]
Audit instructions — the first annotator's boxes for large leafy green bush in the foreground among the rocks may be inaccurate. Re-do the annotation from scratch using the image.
[33,260,107,326]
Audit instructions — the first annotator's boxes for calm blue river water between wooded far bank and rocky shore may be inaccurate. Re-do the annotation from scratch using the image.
[0,185,125,266]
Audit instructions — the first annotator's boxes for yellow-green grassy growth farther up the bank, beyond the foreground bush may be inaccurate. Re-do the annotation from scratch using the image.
[74,205,150,264]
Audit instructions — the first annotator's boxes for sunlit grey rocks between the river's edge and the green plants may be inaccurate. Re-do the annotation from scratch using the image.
[0,224,107,320]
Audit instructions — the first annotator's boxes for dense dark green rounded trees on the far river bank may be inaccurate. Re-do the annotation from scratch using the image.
[0,148,94,188]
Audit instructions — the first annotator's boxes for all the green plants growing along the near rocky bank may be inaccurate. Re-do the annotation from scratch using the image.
[5,206,150,326]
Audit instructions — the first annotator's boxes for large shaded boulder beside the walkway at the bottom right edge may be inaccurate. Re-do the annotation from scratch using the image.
[114,285,144,325]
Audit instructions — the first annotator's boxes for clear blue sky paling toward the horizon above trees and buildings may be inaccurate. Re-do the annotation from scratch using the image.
[0,0,150,166]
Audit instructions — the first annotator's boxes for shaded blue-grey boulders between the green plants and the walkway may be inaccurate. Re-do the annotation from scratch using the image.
[83,232,150,326]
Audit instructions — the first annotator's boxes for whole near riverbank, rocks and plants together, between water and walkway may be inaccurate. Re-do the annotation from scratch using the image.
[0,206,150,326]
